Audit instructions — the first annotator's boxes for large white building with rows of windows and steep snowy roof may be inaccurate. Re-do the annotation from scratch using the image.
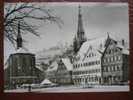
[73,37,108,85]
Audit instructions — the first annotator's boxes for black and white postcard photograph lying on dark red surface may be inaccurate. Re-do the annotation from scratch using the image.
[4,2,130,93]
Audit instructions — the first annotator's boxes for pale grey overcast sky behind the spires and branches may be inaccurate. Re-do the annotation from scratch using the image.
[4,3,129,59]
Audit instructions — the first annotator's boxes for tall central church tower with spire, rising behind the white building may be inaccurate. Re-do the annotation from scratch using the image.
[73,6,86,53]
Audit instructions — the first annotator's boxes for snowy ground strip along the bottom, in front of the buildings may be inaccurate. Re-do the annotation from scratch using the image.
[5,86,129,93]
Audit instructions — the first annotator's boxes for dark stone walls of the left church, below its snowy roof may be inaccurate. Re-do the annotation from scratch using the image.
[5,53,38,88]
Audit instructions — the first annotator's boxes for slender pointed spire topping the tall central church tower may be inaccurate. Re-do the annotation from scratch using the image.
[77,5,84,34]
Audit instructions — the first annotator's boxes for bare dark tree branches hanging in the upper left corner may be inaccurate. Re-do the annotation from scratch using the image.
[4,3,62,48]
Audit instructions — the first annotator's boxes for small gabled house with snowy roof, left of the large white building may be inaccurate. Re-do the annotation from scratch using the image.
[46,58,72,85]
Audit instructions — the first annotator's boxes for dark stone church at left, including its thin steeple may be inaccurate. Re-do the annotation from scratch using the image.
[4,24,41,89]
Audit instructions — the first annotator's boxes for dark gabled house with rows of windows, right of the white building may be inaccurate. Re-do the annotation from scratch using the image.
[102,40,129,85]
